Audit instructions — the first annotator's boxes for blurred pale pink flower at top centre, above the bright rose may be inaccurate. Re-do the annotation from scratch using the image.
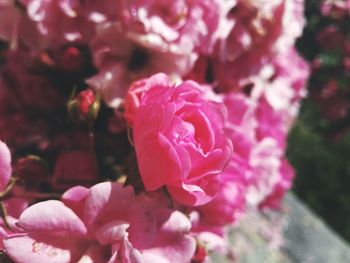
[122,0,223,54]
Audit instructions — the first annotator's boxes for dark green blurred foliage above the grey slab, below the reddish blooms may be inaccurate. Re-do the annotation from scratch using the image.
[287,99,350,241]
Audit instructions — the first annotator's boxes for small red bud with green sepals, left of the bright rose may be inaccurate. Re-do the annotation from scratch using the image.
[67,89,100,122]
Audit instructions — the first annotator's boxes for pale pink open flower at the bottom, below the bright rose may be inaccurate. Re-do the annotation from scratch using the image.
[4,182,195,263]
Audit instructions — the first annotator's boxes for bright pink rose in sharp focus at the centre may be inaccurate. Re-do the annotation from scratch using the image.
[125,74,232,206]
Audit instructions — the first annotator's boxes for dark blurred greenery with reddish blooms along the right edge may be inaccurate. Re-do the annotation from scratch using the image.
[287,0,350,242]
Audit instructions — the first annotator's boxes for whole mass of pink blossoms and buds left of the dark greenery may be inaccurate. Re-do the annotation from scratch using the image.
[0,0,309,263]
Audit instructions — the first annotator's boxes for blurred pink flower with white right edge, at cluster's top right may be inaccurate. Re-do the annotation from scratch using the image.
[213,0,304,91]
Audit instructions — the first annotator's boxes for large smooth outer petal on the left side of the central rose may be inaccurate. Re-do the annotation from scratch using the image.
[134,104,182,191]
